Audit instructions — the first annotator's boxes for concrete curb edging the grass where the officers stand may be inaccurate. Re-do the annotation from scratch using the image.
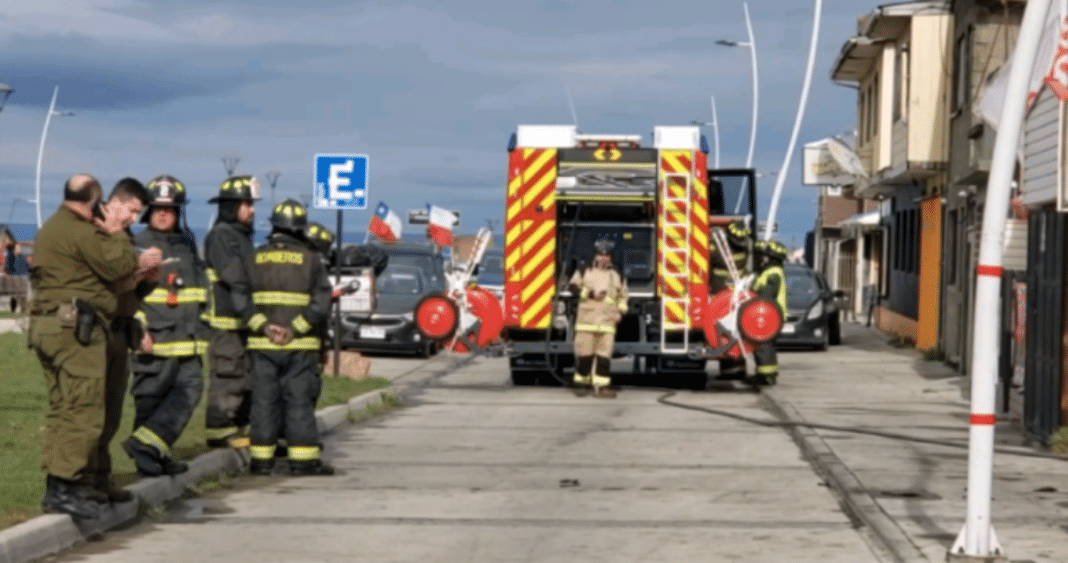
[0,386,399,563]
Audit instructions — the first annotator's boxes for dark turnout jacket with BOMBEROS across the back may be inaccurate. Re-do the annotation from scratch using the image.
[247,233,332,351]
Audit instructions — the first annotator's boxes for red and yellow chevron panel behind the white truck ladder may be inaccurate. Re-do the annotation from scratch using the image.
[657,151,708,327]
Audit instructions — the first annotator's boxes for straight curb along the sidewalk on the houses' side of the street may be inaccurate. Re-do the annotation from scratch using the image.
[761,388,930,563]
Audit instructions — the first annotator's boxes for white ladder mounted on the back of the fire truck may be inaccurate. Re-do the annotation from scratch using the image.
[660,172,692,354]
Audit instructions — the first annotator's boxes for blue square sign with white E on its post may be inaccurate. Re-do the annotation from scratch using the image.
[312,154,370,377]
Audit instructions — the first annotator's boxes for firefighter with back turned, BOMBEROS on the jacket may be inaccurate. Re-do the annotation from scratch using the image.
[247,200,334,475]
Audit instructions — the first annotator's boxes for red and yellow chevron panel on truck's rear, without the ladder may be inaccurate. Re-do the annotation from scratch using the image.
[504,148,556,328]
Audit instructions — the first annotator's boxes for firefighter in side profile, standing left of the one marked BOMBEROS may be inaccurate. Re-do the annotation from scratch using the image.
[204,176,260,448]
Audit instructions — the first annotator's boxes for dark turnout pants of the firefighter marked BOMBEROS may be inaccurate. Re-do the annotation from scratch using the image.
[249,350,321,462]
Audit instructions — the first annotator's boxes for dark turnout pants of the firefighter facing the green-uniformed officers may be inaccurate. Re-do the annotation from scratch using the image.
[130,355,204,456]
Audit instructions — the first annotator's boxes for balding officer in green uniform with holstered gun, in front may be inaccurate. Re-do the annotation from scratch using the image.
[28,174,159,518]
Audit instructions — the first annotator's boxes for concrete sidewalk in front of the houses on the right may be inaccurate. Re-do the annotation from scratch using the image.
[765,325,1068,563]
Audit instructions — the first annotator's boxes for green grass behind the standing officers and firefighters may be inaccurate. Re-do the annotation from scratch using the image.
[0,332,390,529]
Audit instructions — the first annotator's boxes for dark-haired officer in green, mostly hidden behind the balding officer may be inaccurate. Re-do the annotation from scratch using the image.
[90,177,159,502]
